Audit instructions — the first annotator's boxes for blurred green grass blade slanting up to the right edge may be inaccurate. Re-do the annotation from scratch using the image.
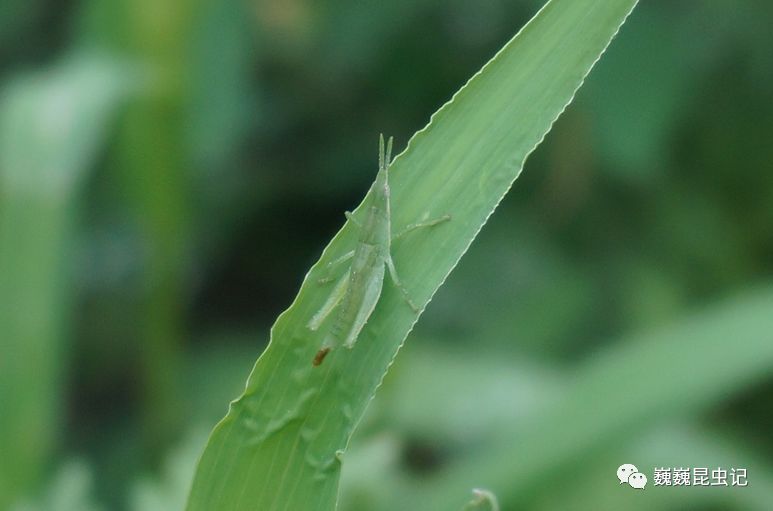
[398,288,773,511]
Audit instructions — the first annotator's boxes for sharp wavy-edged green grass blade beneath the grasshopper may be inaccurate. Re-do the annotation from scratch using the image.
[188,0,636,511]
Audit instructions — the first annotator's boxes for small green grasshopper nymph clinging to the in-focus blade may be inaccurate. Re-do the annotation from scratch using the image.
[307,135,451,366]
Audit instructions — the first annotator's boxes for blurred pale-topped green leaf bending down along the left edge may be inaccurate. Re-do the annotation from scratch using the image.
[0,55,127,509]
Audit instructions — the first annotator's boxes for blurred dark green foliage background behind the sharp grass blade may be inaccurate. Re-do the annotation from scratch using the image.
[0,0,773,511]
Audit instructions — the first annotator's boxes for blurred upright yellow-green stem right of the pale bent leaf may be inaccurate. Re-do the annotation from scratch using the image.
[121,0,194,462]
